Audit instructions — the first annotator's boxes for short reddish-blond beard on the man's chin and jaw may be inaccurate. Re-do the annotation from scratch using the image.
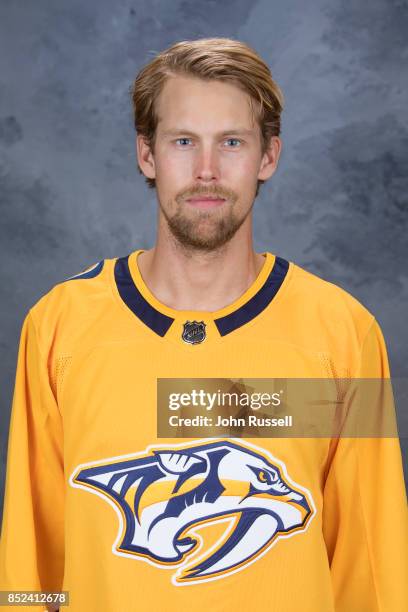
[161,198,252,252]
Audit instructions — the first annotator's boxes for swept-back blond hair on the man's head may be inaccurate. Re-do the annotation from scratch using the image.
[130,38,284,193]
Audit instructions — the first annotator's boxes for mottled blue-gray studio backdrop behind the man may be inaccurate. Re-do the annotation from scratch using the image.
[0,0,408,520]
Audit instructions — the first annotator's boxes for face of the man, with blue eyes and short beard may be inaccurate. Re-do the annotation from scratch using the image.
[138,76,279,251]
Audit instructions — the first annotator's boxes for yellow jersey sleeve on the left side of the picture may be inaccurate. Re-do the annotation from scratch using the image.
[0,311,64,611]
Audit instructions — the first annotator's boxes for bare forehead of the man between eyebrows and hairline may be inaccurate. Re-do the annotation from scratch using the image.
[155,75,257,132]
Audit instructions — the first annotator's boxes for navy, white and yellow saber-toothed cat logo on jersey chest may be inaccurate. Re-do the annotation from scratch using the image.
[70,439,315,586]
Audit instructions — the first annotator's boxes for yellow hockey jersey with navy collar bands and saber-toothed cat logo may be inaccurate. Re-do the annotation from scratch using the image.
[0,249,408,612]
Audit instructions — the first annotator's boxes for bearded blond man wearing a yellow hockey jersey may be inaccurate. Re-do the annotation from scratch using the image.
[0,39,408,612]
